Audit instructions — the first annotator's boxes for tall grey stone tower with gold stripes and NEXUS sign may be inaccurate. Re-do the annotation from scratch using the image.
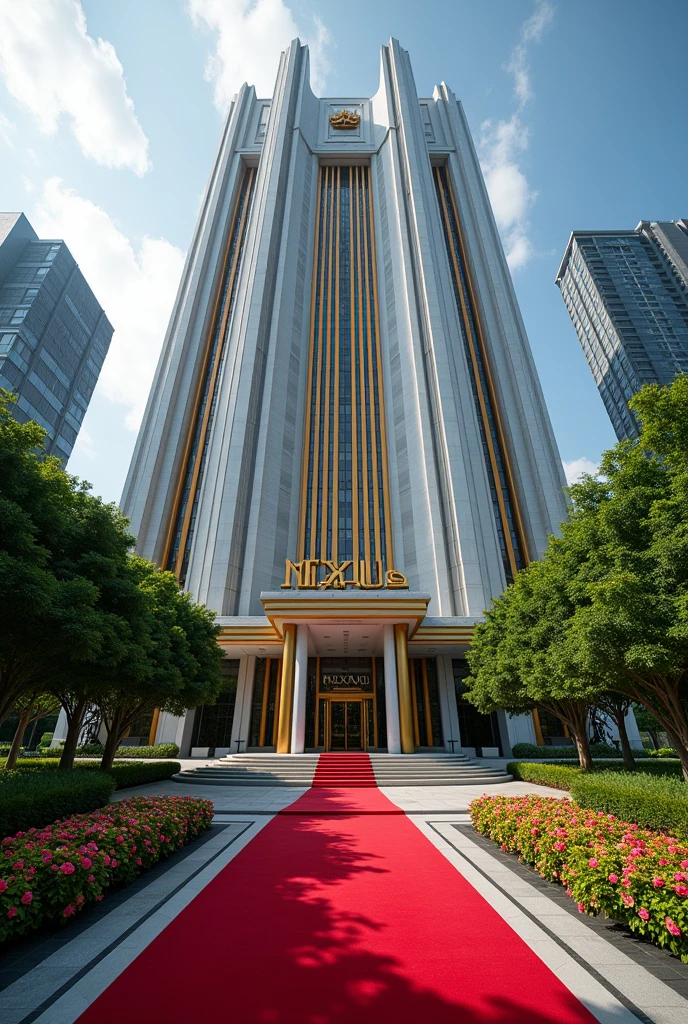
[123,40,565,753]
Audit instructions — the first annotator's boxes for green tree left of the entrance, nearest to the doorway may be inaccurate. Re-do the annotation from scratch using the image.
[97,556,222,770]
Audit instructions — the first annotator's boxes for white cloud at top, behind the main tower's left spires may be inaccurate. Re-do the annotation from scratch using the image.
[187,0,330,114]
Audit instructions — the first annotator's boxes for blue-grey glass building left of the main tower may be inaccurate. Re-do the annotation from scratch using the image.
[0,213,113,463]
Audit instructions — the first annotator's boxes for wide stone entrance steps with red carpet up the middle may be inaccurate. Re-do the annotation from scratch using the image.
[173,754,512,787]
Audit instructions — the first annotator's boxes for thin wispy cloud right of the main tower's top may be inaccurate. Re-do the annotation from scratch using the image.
[478,0,554,270]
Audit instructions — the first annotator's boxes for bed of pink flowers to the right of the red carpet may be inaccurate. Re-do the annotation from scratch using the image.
[470,796,688,963]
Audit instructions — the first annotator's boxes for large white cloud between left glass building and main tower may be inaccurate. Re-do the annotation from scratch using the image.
[31,178,184,430]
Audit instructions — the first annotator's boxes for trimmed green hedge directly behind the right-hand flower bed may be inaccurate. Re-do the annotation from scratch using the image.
[571,771,688,835]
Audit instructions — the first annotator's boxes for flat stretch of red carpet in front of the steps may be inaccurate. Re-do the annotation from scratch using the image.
[79,791,595,1024]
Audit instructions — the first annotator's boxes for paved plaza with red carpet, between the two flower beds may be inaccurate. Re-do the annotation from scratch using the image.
[0,770,688,1024]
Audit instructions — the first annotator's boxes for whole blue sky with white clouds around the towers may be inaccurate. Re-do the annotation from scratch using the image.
[0,0,688,500]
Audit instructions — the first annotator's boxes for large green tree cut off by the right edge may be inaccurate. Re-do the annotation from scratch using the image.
[569,377,688,778]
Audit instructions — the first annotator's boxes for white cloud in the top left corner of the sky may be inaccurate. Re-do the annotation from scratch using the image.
[0,0,151,175]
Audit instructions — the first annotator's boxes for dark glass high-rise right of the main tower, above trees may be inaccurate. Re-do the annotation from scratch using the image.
[556,220,688,439]
